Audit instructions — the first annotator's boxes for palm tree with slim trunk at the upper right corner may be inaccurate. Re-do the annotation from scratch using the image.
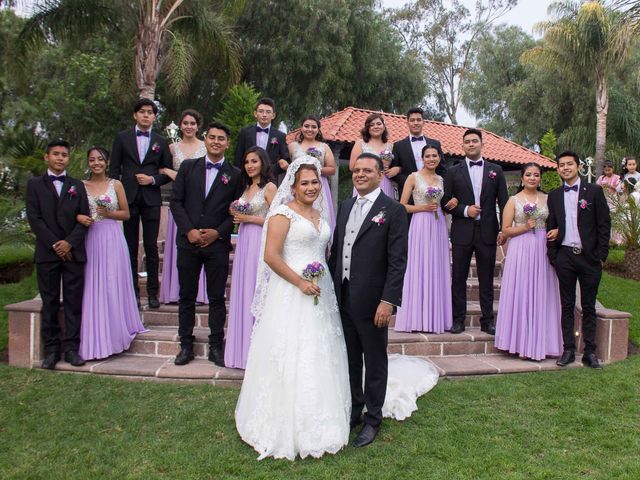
[522,0,637,175]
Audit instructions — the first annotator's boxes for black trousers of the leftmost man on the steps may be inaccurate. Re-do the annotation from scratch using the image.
[36,262,84,354]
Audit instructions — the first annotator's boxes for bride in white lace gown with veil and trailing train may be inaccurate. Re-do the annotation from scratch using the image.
[235,156,438,460]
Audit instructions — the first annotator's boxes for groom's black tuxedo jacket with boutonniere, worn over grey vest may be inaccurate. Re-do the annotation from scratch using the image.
[329,192,408,318]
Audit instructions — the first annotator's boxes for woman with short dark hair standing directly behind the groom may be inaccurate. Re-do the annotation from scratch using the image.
[349,113,398,200]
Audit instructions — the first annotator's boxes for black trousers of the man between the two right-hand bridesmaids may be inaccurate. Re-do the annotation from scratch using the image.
[451,221,496,325]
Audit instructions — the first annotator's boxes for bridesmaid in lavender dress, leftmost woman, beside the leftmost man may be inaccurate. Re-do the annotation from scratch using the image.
[77,147,145,360]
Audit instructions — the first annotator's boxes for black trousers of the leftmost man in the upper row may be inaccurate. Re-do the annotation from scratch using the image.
[123,188,160,297]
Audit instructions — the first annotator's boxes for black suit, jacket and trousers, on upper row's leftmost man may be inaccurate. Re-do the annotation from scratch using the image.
[109,128,173,295]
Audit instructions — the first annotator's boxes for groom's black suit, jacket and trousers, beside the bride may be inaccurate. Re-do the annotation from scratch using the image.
[329,192,408,426]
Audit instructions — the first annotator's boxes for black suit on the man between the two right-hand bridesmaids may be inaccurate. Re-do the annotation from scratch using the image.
[442,159,509,325]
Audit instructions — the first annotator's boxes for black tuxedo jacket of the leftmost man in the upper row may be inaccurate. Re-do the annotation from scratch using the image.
[109,128,173,206]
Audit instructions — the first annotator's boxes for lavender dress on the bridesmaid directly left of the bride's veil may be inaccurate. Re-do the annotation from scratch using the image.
[224,188,269,368]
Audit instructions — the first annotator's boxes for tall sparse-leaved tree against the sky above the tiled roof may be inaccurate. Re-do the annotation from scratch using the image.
[391,0,517,124]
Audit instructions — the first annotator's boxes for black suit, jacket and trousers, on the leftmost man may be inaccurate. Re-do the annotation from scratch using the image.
[27,174,89,354]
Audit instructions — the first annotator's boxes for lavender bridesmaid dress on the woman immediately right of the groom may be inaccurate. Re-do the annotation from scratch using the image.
[394,172,453,333]
